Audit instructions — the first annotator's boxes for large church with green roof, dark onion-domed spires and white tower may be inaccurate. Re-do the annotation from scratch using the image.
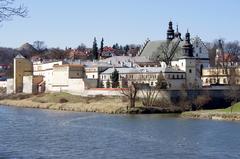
[138,21,209,88]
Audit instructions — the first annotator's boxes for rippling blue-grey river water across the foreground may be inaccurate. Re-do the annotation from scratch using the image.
[0,106,240,159]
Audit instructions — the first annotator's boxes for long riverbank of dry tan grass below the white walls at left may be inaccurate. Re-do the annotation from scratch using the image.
[0,93,182,114]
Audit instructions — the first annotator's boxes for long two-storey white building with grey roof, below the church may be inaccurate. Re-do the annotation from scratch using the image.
[100,67,186,89]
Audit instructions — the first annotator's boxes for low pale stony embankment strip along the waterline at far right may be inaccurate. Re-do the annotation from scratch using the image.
[181,110,240,121]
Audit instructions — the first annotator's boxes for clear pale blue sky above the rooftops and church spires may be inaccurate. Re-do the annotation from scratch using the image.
[0,0,240,48]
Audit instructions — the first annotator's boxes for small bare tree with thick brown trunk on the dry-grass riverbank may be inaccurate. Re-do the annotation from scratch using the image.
[121,82,139,108]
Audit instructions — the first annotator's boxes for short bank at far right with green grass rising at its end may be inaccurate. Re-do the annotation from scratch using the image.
[182,103,240,121]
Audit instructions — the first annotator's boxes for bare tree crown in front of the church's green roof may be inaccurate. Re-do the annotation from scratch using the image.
[152,39,181,66]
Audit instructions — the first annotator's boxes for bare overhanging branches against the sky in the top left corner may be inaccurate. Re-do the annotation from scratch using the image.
[0,0,28,23]
